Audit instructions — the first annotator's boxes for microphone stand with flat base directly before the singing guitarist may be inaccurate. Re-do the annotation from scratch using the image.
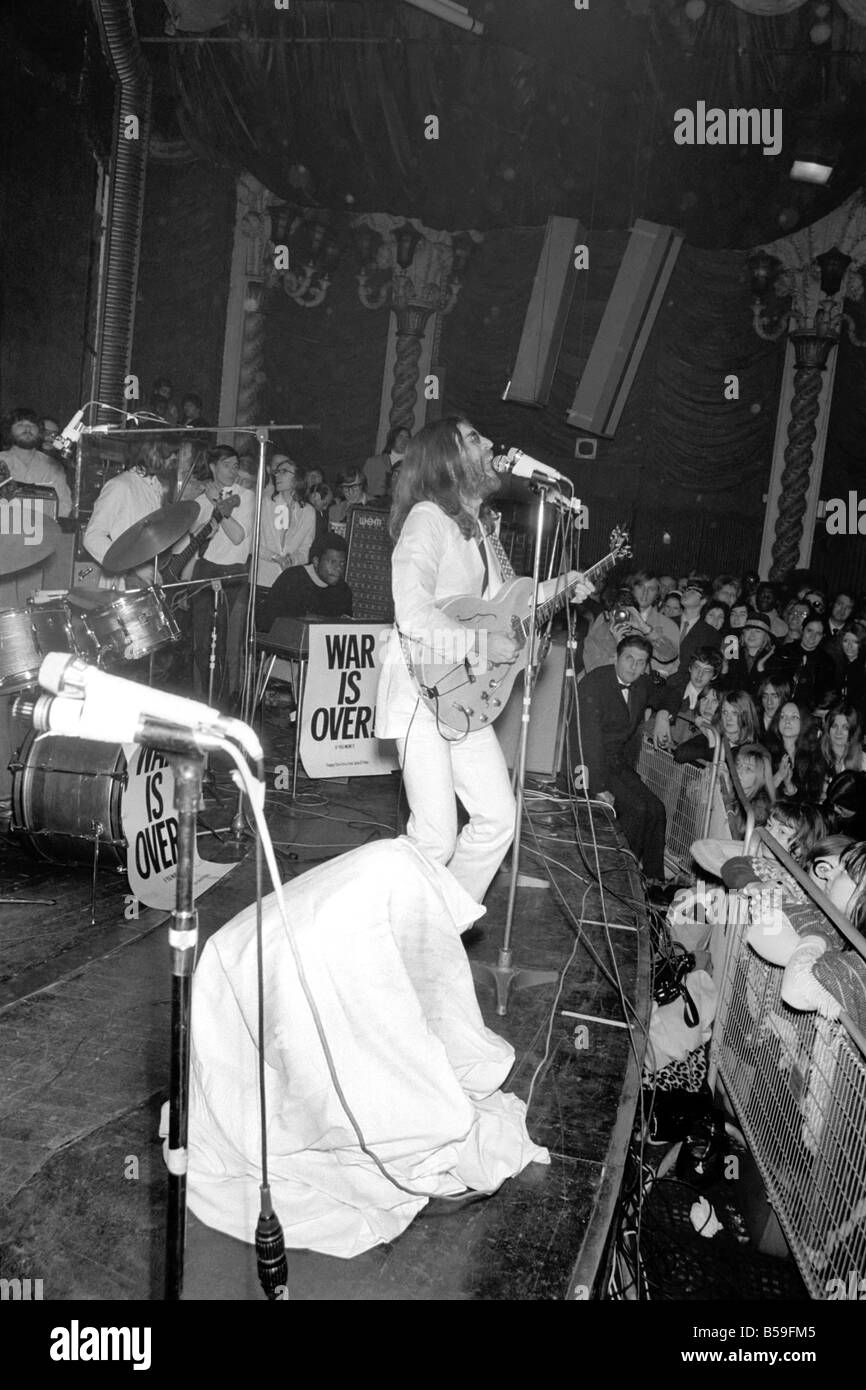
[471,478,572,1017]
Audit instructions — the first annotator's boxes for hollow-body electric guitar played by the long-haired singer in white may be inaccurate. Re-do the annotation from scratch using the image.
[402,527,631,734]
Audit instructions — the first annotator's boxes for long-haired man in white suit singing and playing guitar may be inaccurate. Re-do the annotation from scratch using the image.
[375,417,591,902]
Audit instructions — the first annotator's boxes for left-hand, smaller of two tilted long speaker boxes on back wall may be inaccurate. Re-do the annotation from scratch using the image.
[502,217,587,406]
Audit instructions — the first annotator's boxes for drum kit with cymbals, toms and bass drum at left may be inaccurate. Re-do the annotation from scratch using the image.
[0,502,209,872]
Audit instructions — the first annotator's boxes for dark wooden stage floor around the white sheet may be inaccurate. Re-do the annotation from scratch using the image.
[0,716,651,1300]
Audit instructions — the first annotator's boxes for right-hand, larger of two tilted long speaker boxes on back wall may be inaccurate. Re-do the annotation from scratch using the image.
[569,220,683,438]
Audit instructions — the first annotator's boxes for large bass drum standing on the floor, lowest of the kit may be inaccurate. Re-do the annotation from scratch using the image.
[11,731,126,869]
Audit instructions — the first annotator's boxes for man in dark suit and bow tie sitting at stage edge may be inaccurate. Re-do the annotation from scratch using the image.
[578,637,666,884]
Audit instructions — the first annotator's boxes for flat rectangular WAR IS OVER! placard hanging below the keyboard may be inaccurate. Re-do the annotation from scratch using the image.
[300,623,398,778]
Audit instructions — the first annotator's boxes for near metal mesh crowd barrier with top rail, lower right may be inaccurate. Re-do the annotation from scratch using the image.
[710,830,866,1298]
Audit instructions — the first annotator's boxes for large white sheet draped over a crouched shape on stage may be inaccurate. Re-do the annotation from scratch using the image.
[188,838,549,1257]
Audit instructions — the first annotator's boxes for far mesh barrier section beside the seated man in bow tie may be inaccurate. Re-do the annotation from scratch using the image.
[637,730,730,873]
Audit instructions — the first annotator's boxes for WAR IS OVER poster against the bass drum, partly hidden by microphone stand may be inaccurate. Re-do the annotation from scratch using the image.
[121,744,235,908]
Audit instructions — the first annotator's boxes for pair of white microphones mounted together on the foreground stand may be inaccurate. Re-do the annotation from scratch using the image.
[39,652,264,759]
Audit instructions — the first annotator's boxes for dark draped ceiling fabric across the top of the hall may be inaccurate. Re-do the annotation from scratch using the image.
[147,0,866,249]
